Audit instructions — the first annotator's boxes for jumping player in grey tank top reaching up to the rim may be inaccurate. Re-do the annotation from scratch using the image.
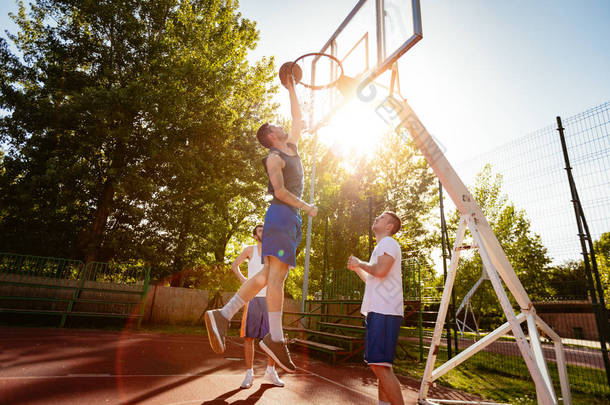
[205,70,318,373]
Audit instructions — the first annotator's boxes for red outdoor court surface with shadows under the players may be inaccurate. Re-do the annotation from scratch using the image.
[0,328,478,405]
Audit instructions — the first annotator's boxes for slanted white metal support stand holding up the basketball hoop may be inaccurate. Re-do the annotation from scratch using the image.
[386,97,571,405]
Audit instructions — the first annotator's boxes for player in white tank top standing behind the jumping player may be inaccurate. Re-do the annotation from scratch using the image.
[231,224,284,388]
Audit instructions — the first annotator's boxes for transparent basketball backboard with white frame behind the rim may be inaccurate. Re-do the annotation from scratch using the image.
[308,0,422,128]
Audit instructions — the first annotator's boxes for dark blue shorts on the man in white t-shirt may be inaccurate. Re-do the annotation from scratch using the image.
[364,312,402,367]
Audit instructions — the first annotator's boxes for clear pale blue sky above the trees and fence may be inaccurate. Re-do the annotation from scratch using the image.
[0,0,610,162]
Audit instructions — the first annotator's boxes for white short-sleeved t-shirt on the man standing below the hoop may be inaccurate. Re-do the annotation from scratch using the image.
[360,236,404,316]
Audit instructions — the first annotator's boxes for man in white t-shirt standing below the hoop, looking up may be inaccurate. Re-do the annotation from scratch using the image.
[347,211,404,405]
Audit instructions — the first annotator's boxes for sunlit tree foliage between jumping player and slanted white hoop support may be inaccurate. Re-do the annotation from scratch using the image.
[286,131,438,298]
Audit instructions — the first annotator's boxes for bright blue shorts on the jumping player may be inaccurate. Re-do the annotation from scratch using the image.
[261,204,301,267]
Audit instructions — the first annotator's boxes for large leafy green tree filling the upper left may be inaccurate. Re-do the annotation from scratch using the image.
[0,0,275,276]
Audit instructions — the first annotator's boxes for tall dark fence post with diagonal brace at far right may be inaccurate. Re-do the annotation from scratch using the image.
[557,117,610,385]
